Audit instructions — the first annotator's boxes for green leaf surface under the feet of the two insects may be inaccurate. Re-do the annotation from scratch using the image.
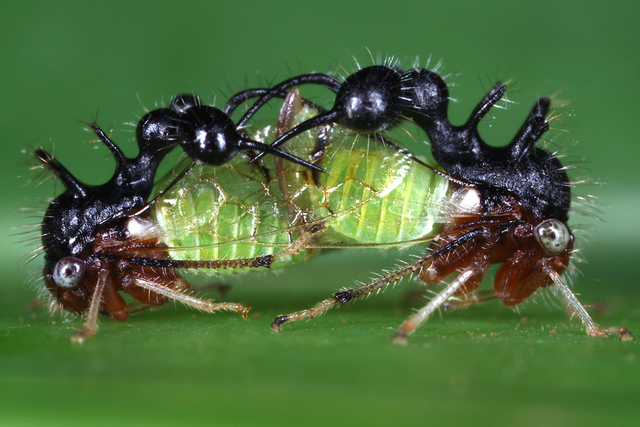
[0,252,640,425]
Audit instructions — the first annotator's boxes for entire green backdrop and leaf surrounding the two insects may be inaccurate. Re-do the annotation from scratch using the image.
[0,0,640,426]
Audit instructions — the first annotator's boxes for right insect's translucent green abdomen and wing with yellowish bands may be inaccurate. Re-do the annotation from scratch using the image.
[304,135,448,247]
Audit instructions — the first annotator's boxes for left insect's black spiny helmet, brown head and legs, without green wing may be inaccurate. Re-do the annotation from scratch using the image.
[35,95,322,341]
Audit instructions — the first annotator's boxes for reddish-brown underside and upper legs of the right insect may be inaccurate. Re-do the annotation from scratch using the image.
[420,192,573,306]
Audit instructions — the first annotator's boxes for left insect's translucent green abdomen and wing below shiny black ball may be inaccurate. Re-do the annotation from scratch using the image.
[154,156,312,260]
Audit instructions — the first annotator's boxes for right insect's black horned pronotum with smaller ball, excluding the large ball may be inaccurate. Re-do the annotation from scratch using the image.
[402,69,571,222]
